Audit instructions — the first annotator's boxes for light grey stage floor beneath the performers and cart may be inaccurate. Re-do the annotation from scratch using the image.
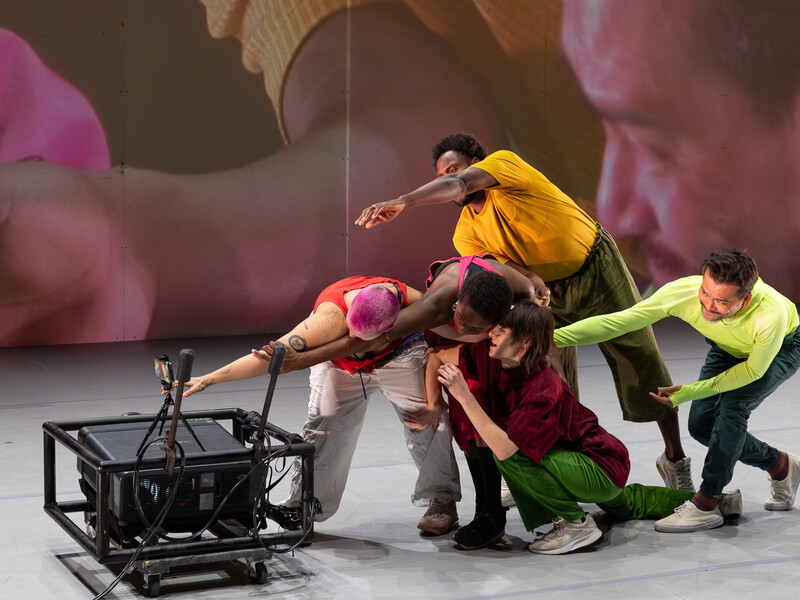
[0,316,800,600]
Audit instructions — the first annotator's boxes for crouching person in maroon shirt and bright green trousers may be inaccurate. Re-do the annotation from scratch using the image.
[426,301,741,554]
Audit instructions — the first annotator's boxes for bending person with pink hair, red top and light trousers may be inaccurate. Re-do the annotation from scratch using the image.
[184,277,461,535]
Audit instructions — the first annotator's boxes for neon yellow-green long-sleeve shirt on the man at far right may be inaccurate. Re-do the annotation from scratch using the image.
[554,275,800,406]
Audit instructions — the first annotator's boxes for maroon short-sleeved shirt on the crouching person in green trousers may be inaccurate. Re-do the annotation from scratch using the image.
[460,340,631,487]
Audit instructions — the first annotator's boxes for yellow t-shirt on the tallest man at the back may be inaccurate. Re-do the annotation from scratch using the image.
[453,150,597,281]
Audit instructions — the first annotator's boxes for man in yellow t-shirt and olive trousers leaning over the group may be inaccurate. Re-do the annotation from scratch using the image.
[356,133,694,532]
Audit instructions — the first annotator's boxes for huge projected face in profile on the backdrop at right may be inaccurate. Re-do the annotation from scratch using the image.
[563,0,800,292]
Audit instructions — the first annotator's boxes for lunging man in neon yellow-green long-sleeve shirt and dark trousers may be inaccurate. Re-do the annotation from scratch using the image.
[554,250,800,532]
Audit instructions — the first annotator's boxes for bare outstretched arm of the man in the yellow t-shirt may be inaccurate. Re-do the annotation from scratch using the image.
[356,169,497,229]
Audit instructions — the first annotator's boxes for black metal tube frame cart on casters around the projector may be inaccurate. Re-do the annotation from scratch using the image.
[42,408,314,596]
